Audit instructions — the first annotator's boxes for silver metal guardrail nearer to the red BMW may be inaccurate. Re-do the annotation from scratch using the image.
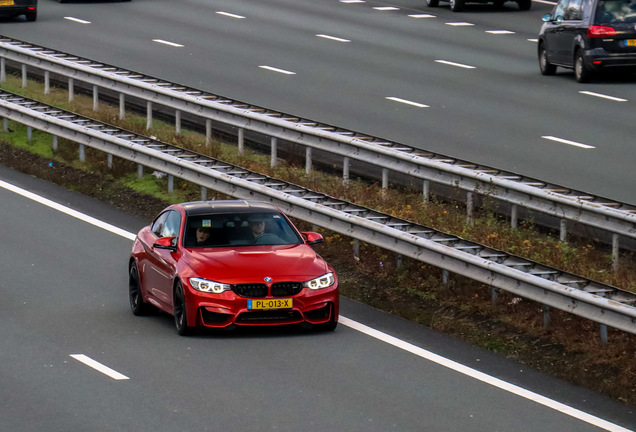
[0,91,636,334]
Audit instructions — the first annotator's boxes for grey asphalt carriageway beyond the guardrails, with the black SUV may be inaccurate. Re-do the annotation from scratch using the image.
[1,0,636,203]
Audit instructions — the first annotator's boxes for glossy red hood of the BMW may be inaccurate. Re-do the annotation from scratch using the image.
[188,244,329,284]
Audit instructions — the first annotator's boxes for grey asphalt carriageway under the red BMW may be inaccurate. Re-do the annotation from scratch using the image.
[0,167,636,432]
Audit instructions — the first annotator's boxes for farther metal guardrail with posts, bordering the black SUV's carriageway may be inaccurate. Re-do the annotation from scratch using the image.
[0,36,636,260]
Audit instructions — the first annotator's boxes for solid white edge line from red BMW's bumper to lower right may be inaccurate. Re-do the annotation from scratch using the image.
[338,316,633,432]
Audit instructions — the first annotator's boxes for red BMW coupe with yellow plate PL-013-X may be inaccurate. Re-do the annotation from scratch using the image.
[128,200,339,335]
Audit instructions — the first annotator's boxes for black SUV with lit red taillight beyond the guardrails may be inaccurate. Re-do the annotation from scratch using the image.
[539,0,636,83]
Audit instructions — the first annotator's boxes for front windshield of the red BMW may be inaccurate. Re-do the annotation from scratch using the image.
[184,212,303,248]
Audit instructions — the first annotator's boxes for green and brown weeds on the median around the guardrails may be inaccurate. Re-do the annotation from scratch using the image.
[0,72,636,406]
